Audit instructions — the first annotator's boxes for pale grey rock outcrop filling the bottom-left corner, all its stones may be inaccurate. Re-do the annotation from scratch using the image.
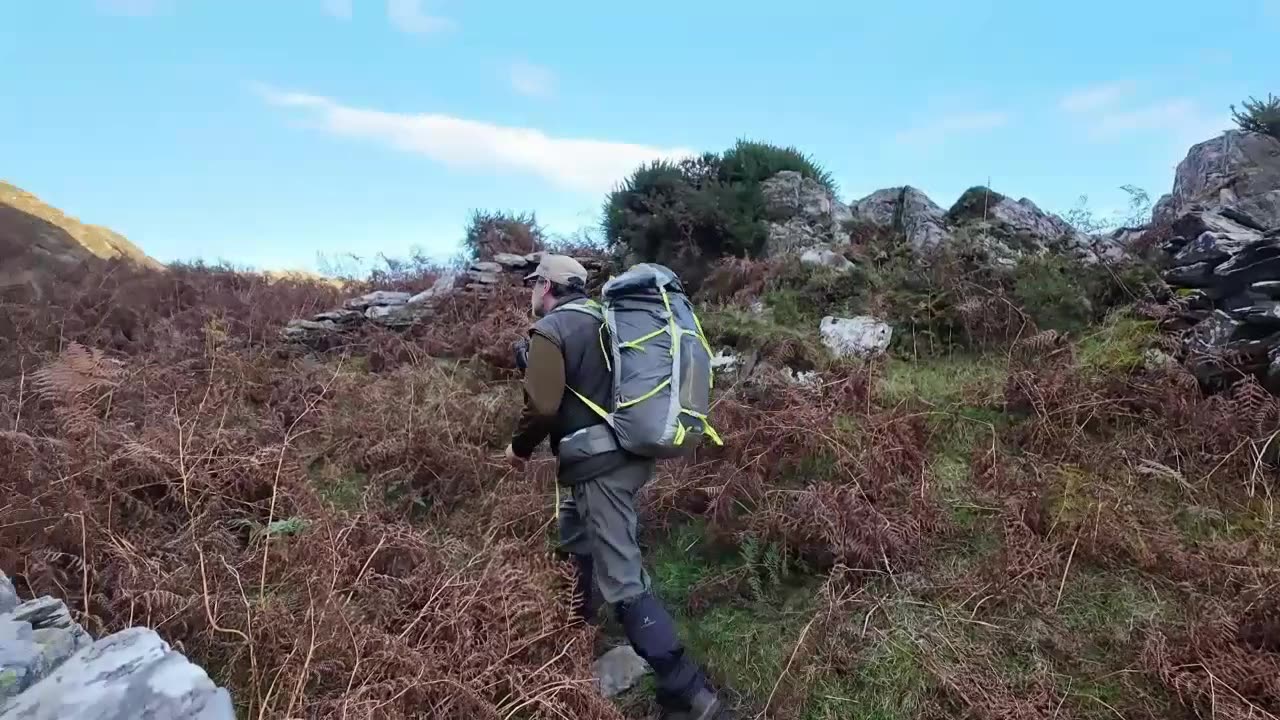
[0,574,236,720]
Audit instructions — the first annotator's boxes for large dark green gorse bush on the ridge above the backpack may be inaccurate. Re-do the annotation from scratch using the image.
[603,141,835,288]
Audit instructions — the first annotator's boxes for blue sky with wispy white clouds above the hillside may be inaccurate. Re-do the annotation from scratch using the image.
[0,0,1280,269]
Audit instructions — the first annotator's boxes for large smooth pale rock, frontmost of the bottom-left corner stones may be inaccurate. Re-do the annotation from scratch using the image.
[0,628,236,720]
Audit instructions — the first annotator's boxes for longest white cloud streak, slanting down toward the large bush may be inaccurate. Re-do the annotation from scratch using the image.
[256,86,692,192]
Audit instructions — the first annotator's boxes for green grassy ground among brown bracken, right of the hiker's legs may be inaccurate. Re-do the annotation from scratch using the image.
[609,318,1249,720]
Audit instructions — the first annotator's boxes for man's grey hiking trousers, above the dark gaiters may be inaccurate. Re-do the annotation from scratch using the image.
[558,459,655,606]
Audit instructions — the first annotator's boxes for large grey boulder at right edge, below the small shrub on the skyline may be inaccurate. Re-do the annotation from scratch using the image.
[1152,131,1280,229]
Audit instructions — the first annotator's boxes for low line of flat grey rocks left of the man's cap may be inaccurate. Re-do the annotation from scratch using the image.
[282,252,604,348]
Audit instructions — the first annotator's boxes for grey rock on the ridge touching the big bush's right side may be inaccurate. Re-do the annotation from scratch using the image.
[760,170,851,255]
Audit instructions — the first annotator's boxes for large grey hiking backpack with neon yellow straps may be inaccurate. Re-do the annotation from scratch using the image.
[561,263,723,459]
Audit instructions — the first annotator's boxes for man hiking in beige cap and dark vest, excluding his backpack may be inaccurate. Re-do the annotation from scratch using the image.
[507,255,722,720]
